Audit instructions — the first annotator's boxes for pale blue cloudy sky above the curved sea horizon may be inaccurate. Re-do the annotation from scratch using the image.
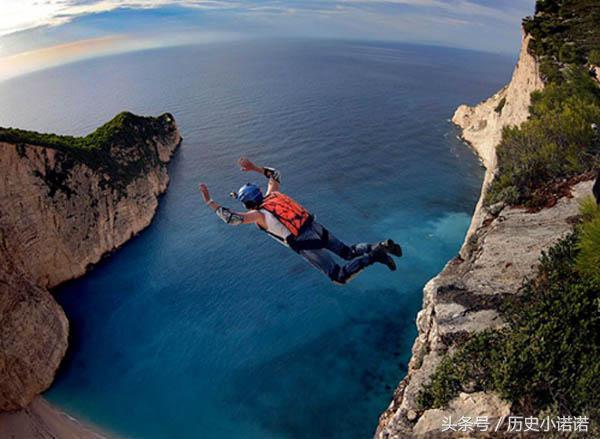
[0,0,535,80]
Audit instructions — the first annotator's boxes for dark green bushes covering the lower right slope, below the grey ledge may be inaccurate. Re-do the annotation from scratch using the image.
[419,201,600,417]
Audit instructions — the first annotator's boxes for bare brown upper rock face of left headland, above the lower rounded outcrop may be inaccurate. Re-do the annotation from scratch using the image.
[0,115,180,287]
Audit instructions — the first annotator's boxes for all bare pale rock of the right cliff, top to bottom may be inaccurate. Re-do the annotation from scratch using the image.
[375,31,572,438]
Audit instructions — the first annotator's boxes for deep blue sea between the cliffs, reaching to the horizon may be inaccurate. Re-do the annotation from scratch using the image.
[0,41,514,439]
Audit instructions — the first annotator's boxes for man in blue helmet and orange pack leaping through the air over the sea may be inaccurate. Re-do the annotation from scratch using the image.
[199,158,402,284]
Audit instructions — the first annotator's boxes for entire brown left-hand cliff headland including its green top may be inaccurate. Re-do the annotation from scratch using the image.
[0,113,181,410]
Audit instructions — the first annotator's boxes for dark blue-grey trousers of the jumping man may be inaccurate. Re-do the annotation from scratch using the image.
[290,221,375,284]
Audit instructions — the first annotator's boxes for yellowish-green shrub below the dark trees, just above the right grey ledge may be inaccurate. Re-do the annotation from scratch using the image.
[487,68,600,207]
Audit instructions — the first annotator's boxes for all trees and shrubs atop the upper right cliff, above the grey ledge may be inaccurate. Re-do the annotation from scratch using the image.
[486,0,600,208]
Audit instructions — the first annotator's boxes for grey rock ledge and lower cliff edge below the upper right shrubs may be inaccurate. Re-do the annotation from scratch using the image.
[377,181,592,438]
